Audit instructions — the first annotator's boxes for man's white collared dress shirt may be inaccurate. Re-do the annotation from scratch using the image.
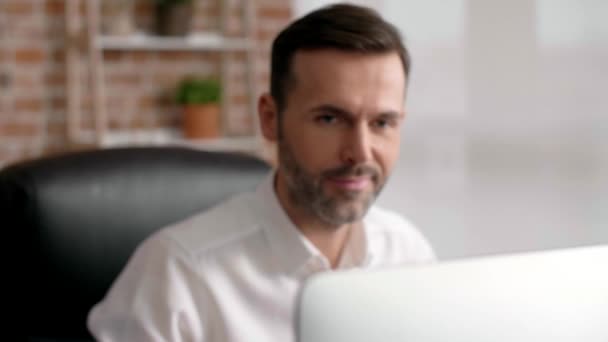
[88,177,435,342]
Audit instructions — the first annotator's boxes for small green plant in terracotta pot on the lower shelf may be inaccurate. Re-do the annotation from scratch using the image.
[176,78,221,139]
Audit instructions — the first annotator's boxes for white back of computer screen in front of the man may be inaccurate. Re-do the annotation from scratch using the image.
[295,245,608,342]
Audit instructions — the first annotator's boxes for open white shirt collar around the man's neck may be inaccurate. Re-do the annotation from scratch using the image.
[256,172,373,276]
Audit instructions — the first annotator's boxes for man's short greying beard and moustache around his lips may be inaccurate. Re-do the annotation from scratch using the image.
[278,138,384,226]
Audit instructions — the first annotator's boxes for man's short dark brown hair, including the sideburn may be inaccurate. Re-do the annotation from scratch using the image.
[270,4,410,113]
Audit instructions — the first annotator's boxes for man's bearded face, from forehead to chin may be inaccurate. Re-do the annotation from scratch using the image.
[264,50,406,226]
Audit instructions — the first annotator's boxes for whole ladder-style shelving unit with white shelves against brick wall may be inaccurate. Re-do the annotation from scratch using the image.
[65,0,264,155]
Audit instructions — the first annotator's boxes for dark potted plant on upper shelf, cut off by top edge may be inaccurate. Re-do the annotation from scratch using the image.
[154,0,193,36]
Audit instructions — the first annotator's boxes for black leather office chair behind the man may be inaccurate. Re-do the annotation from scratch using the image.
[0,147,269,341]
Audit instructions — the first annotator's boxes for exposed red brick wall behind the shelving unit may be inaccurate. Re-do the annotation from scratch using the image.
[0,0,291,167]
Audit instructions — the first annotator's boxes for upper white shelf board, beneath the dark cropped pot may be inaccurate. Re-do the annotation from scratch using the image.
[95,32,254,51]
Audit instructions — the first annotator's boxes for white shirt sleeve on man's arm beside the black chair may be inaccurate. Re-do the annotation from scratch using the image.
[87,234,211,342]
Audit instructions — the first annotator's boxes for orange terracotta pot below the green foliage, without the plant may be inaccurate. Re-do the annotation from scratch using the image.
[182,103,220,139]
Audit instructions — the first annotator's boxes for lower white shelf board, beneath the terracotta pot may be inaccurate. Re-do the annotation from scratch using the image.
[101,129,260,153]
